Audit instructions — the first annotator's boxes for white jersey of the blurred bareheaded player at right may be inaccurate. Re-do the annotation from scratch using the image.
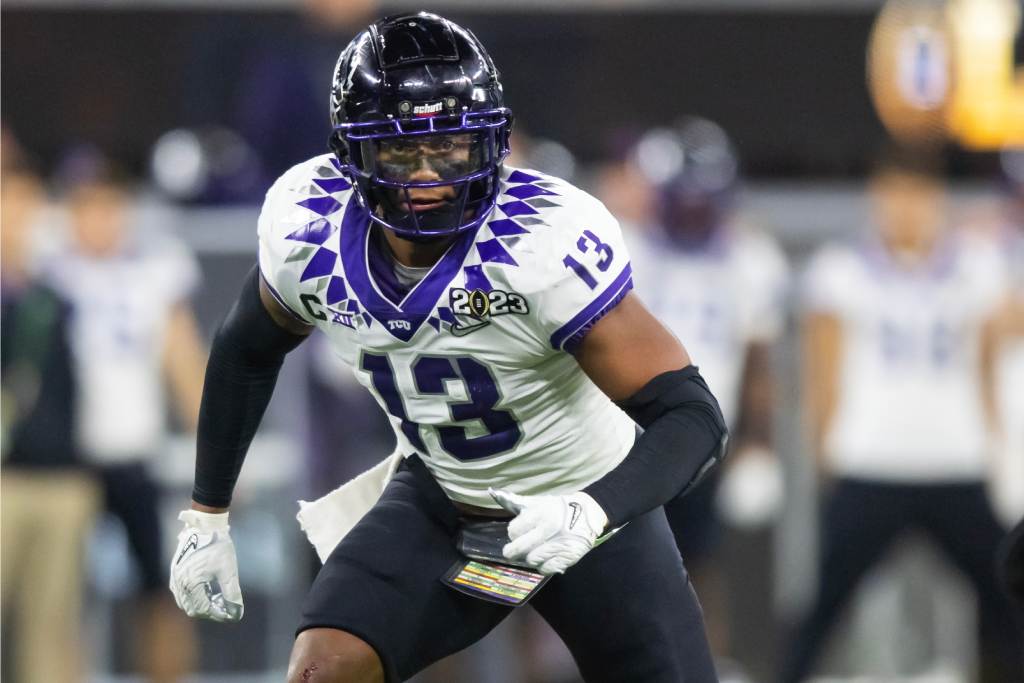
[804,238,1007,482]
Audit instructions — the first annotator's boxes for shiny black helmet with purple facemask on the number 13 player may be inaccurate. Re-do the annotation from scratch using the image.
[330,12,512,240]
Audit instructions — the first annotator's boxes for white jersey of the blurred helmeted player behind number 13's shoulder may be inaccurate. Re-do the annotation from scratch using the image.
[628,226,790,424]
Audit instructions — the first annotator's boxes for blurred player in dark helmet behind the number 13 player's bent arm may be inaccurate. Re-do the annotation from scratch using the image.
[628,117,788,680]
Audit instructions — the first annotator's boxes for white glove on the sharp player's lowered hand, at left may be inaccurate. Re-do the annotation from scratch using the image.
[171,510,244,622]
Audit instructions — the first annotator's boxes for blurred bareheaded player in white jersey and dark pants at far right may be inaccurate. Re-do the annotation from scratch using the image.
[780,147,1024,683]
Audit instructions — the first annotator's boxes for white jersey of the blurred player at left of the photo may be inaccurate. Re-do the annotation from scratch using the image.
[45,233,199,463]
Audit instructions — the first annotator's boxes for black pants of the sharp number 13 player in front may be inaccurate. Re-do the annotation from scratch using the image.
[298,458,717,683]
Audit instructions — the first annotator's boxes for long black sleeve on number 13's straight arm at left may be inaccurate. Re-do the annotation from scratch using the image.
[193,266,306,508]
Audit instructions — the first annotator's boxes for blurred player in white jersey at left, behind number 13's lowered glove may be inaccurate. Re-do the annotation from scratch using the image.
[44,148,206,682]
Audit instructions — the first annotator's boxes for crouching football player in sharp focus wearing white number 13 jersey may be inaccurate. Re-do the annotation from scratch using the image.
[171,13,726,683]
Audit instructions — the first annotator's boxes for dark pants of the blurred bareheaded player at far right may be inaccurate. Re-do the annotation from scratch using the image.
[780,479,1024,683]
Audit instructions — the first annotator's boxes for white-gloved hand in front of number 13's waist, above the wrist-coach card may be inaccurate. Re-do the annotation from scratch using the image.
[487,488,608,574]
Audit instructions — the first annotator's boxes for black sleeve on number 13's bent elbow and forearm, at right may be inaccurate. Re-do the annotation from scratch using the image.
[584,366,728,529]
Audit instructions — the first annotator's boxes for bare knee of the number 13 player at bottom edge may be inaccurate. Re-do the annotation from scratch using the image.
[288,629,384,683]
